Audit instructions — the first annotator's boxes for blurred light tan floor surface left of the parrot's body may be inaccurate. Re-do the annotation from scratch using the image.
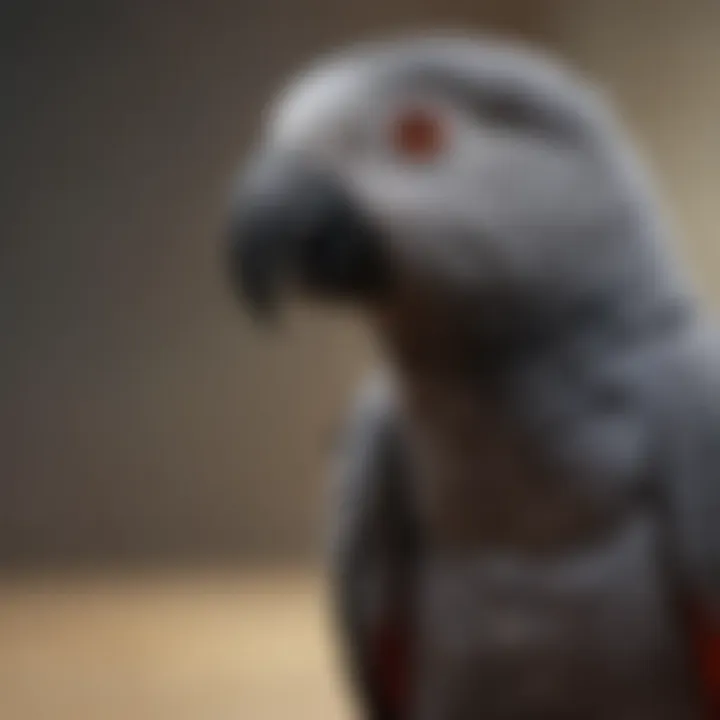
[0,573,351,720]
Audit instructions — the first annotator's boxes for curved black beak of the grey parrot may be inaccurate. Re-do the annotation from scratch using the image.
[230,152,390,312]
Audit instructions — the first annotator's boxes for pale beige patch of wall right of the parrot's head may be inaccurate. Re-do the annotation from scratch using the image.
[551,0,720,305]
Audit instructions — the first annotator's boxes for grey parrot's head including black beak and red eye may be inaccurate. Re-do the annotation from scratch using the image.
[230,32,688,372]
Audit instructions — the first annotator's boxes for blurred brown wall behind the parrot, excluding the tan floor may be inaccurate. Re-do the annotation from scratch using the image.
[0,0,720,561]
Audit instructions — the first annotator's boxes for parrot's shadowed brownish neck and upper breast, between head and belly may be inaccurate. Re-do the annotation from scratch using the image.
[380,282,693,552]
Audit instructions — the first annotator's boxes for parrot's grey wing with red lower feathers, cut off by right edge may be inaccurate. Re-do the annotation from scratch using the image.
[660,324,720,718]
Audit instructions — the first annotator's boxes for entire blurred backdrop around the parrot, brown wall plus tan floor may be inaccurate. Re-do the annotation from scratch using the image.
[0,0,720,720]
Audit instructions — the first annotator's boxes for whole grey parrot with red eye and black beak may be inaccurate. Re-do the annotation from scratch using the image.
[225,35,720,720]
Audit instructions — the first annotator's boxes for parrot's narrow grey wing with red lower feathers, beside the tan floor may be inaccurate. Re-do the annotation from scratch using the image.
[330,382,419,720]
